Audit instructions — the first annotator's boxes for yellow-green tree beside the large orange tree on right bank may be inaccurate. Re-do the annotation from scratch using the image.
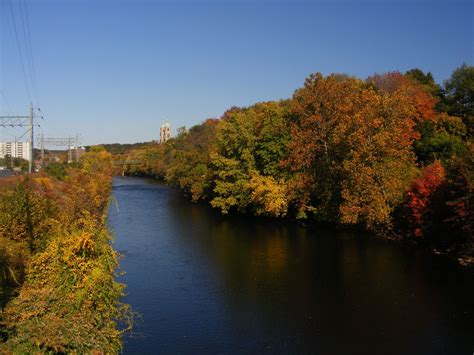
[211,102,289,216]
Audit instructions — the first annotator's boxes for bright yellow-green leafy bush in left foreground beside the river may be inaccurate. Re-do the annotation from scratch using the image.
[2,218,129,353]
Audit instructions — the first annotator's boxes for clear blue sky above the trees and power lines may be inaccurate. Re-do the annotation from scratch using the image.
[0,0,474,144]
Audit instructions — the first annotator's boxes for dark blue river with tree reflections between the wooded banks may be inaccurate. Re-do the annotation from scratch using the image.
[109,178,474,355]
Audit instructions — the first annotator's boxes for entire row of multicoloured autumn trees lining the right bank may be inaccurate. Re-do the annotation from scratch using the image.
[122,65,474,257]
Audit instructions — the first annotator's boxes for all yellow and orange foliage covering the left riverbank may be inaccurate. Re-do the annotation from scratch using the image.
[0,149,129,353]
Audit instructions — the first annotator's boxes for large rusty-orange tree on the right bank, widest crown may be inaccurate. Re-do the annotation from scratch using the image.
[287,74,417,228]
